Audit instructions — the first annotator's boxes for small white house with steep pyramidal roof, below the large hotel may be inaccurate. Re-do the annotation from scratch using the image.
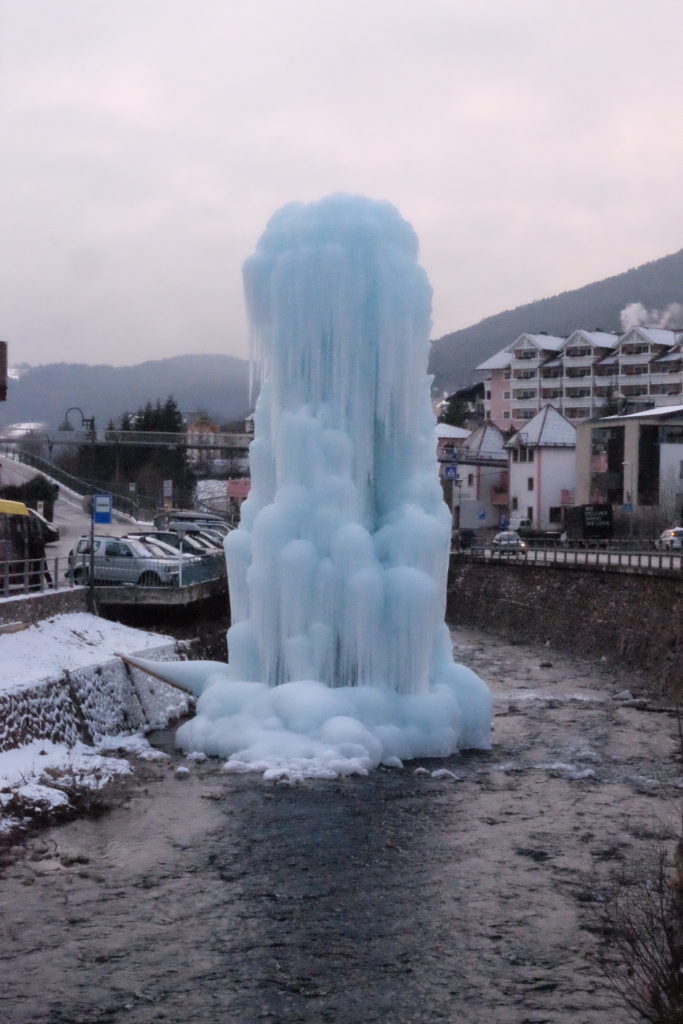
[505,404,577,529]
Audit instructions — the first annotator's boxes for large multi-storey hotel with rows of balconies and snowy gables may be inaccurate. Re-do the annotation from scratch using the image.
[476,327,683,430]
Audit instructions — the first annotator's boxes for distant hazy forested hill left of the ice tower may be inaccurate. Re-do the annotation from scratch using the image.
[0,352,250,427]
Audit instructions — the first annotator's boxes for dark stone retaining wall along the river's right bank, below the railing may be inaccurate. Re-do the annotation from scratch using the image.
[447,555,683,699]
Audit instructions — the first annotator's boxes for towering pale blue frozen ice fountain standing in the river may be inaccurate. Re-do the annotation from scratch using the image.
[125,196,492,778]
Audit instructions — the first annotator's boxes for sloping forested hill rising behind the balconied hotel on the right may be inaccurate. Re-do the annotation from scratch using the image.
[429,249,683,392]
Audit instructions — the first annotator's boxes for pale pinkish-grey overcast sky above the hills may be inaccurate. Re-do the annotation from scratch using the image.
[0,0,683,365]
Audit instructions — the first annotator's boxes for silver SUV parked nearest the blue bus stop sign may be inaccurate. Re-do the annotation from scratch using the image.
[66,537,179,587]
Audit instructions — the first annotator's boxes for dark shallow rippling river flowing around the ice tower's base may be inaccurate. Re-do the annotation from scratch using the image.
[0,631,681,1024]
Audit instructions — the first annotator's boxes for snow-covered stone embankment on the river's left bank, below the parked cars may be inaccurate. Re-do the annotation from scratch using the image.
[0,612,188,836]
